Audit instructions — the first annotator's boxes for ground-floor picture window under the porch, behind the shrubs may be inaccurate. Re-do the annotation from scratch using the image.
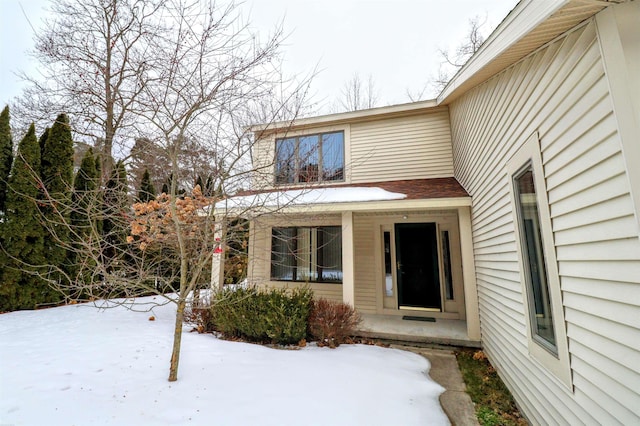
[271,226,342,283]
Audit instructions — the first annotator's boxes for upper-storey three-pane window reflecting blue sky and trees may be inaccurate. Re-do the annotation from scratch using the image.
[276,132,344,184]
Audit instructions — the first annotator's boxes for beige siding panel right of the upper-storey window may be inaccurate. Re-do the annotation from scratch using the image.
[347,109,453,183]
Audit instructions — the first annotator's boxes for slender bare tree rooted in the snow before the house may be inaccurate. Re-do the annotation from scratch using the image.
[24,0,316,381]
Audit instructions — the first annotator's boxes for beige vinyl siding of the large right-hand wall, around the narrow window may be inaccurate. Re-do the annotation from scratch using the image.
[450,21,640,424]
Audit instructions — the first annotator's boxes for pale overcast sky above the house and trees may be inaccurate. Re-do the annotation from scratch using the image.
[0,0,517,112]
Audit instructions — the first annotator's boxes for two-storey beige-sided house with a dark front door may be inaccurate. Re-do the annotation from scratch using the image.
[212,0,640,425]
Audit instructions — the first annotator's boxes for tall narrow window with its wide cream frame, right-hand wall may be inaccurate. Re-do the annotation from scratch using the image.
[506,132,573,389]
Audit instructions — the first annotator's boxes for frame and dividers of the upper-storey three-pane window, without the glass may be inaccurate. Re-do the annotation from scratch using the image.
[273,129,347,186]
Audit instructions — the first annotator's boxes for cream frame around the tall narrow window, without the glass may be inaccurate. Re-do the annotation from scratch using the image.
[507,132,573,389]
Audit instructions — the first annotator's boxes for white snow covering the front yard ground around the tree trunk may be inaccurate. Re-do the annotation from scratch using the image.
[0,296,448,425]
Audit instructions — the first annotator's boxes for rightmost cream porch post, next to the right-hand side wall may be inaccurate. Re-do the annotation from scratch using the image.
[458,207,480,340]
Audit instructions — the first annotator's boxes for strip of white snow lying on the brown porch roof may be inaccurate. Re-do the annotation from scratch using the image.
[217,186,407,208]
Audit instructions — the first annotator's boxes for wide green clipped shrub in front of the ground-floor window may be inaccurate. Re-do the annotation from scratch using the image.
[207,287,313,344]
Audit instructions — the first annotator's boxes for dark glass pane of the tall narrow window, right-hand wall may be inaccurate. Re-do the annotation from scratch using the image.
[514,165,557,353]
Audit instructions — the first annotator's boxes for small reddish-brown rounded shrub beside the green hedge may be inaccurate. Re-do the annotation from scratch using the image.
[309,299,362,348]
